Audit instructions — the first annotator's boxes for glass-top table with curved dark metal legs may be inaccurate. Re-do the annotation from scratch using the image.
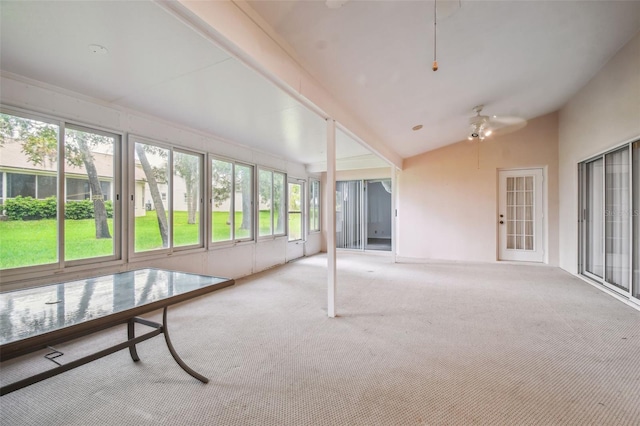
[0,268,234,395]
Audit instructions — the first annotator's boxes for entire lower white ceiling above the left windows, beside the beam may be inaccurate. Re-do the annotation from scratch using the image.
[0,1,376,170]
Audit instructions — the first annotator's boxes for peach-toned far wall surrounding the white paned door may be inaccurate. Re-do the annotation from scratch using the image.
[397,114,558,265]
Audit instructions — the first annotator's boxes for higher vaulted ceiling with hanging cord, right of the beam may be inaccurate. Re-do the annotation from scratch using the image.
[248,0,640,157]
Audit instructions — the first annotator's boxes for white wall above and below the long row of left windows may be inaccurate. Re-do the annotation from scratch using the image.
[0,74,320,290]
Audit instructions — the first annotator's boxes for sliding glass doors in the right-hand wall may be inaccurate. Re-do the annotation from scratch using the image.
[580,142,640,297]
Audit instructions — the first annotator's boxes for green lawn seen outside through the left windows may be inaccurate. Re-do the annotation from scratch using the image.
[0,211,300,269]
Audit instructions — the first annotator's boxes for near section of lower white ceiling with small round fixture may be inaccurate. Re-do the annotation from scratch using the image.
[0,1,229,102]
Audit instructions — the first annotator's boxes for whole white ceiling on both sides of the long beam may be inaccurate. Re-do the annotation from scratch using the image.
[0,0,640,171]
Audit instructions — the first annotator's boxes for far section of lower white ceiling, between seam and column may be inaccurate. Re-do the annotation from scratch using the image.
[117,59,326,163]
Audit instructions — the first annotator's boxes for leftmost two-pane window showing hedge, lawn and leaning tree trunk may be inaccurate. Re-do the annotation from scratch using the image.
[0,113,121,269]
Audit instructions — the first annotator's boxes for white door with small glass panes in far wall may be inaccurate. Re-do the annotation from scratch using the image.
[498,169,545,262]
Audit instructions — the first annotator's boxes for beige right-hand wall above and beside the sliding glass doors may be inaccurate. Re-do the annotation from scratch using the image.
[559,33,640,273]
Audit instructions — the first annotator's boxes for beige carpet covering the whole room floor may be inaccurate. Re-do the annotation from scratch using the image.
[0,253,640,426]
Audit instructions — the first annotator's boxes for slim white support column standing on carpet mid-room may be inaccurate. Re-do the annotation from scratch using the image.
[326,118,336,318]
